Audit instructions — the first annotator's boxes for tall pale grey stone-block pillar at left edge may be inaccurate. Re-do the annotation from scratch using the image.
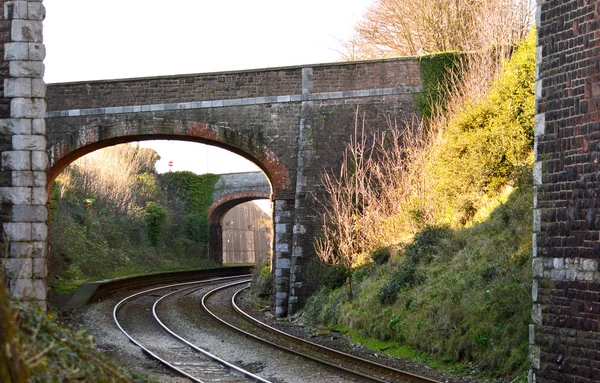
[0,0,48,307]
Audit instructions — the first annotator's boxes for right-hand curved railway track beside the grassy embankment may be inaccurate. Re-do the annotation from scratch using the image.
[202,281,437,383]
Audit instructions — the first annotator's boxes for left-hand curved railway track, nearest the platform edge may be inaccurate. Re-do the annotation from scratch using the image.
[113,277,270,383]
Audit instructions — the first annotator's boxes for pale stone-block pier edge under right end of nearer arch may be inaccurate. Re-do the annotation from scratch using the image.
[271,199,294,317]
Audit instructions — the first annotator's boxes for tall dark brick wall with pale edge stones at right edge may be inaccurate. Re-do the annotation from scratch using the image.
[529,0,600,383]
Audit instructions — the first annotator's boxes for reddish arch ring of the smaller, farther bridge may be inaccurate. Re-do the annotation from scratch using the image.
[208,194,270,264]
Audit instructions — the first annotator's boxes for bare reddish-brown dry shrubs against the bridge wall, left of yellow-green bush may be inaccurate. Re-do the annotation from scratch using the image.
[316,111,430,267]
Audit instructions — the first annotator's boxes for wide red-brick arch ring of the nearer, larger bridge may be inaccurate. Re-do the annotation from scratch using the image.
[47,118,292,198]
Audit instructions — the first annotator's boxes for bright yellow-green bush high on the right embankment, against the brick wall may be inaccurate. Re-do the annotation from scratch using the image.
[427,33,536,225]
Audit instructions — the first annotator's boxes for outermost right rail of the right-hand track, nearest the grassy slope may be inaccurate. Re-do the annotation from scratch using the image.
[231,286,440,383]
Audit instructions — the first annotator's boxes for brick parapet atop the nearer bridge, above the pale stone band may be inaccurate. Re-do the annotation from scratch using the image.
[47,58,421,111]
